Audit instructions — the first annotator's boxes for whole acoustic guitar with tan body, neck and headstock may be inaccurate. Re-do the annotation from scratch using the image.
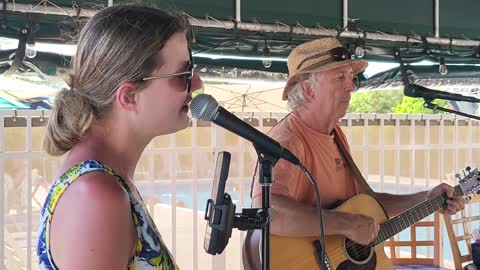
[270,167,480,270]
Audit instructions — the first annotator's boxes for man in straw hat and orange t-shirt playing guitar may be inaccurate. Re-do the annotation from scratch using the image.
[246,38,465,268]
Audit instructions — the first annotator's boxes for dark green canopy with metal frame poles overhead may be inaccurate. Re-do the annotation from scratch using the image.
[0,0,480,73]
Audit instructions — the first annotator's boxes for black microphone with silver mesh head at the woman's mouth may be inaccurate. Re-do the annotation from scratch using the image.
[190,94,300,165]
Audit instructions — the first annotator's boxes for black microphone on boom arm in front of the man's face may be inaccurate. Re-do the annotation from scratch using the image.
[403,84,480,102]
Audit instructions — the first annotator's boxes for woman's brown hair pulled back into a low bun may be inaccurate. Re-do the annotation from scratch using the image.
[44,5,189,156]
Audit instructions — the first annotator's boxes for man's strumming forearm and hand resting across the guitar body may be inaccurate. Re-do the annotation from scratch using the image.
[252,194,379,245]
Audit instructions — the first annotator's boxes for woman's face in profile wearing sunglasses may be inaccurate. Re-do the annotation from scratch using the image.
[137,33,203,136]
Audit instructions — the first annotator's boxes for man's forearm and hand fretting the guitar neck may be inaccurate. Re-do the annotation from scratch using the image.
[375,181,465,217]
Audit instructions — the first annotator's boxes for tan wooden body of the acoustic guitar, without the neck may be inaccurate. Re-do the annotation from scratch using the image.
[270,194,395,270]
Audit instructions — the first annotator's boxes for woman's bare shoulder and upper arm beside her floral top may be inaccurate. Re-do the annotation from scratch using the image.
[51,167,134,268]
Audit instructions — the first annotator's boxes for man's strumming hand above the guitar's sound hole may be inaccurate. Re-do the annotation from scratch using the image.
[346,214,380,246]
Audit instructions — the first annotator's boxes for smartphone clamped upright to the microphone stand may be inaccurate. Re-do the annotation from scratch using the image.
[203,152,235,255]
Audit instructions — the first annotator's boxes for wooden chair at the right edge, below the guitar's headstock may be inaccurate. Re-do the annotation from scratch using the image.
[443,195,480,270]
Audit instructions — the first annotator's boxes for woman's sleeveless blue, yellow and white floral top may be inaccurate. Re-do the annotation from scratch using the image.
[37,160,178,270]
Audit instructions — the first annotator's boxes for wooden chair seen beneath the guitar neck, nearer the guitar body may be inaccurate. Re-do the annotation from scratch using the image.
[385,213,440,267]
